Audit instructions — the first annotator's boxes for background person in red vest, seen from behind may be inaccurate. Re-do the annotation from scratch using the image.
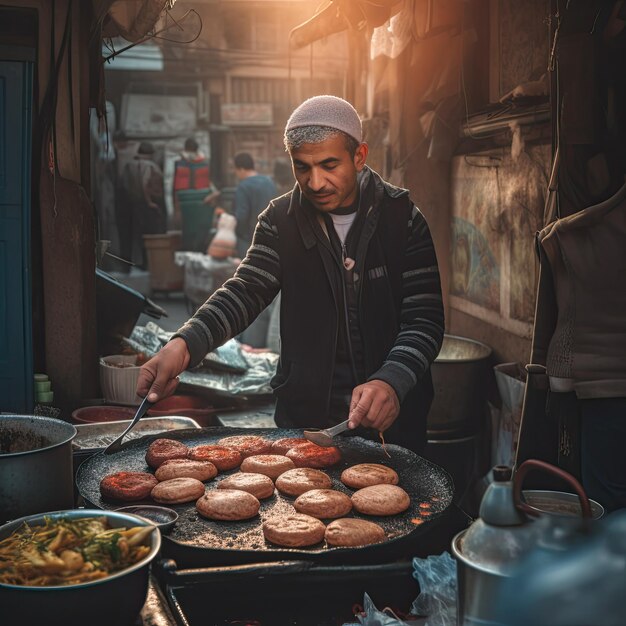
[173,137,220,252]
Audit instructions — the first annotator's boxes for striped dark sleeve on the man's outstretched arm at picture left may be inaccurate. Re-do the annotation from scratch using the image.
[174,208,281,367]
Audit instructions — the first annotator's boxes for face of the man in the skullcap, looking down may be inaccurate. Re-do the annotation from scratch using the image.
[290,135,367,212]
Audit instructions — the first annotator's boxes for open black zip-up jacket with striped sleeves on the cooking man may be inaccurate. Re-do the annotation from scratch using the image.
[177,167,444,451]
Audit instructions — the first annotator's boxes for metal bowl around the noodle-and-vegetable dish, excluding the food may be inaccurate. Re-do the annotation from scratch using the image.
[0,509,161,626]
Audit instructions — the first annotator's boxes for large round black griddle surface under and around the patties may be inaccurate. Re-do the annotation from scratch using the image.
[76,427,454,567]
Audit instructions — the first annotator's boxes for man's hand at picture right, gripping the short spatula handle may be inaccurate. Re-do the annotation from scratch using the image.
[348,380,400,432]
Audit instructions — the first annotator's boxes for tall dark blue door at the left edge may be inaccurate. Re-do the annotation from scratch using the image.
[0,61,33,413]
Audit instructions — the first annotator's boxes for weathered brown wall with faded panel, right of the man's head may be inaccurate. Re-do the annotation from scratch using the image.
[367,0,551,363]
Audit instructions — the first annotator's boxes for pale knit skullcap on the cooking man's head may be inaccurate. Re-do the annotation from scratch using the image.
[285,96,363,143]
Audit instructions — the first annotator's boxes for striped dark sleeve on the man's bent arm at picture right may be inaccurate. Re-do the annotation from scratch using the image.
[369,205,444,402]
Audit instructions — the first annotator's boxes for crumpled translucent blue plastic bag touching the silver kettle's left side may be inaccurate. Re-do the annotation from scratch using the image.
[411,552,457,626]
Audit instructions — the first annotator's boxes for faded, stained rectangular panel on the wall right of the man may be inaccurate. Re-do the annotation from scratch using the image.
[448,145,550,363]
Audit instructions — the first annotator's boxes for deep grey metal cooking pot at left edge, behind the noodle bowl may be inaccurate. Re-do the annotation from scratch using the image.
[0,415,76,522]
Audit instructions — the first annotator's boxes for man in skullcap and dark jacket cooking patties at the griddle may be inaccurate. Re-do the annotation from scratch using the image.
[137,96,444,452]
